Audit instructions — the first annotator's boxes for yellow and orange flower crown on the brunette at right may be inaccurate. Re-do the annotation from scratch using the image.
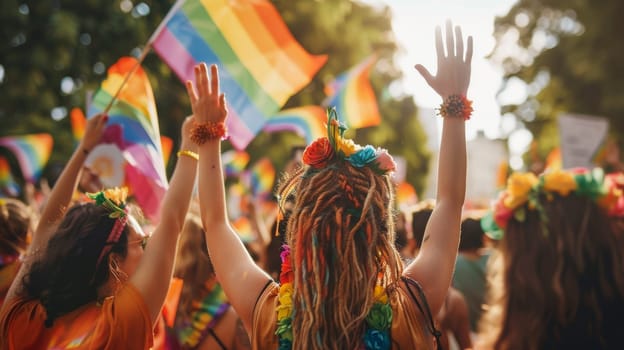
[491,168,624,230]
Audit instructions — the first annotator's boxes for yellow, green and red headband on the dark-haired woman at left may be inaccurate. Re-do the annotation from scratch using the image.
[87,187,128,268]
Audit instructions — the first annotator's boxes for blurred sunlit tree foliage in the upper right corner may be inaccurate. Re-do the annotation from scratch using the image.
[490,0,624,157]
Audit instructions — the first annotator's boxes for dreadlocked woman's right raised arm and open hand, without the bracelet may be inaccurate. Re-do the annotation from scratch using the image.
[405,21,472,315]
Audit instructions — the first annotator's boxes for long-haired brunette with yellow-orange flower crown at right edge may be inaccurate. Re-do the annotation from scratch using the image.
[479,169,624,350]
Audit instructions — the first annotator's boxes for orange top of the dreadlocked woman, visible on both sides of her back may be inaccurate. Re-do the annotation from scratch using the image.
[250,283,433,349]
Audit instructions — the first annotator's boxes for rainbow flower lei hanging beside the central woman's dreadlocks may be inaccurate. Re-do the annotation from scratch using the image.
[275,245,392,350]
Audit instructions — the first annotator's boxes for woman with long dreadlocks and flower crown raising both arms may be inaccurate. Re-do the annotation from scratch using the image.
[188,22,472,349]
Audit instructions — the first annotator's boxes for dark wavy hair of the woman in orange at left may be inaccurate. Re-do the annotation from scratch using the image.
[23,203,129,327]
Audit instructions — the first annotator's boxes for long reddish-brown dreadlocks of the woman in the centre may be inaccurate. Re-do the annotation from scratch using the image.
[281,160,402,349]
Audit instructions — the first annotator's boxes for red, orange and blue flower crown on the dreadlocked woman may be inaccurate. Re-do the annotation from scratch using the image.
[303,108,396,175]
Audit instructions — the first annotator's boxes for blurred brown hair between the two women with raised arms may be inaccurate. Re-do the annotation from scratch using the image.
[173,214,215,323]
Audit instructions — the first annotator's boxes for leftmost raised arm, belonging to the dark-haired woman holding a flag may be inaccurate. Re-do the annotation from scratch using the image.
[4,114,108,305]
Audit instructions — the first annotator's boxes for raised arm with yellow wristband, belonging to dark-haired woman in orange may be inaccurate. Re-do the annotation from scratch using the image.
[130,117,197,322]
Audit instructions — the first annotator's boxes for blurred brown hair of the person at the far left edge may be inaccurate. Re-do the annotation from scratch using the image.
[0,198,35,258]
